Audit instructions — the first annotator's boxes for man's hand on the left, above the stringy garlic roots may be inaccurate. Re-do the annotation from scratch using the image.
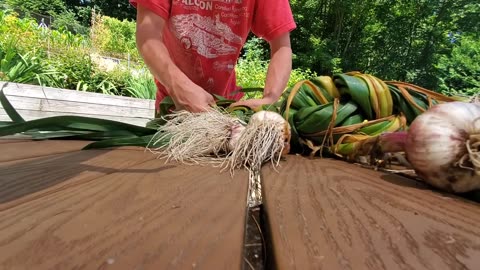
[169,83,215,113]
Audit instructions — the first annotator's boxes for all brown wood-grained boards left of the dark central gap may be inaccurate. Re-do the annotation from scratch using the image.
[0,141,248,270]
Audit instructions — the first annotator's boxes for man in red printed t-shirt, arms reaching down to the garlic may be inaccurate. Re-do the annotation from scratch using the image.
[130,0,296,115]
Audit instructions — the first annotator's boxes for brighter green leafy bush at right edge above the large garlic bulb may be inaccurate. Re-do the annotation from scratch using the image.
[437,36,480,96]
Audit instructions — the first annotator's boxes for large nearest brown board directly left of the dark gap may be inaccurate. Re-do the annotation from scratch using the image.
[0,160,248,270]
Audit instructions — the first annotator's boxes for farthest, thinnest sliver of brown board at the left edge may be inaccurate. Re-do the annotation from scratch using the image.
[0,140,91,162]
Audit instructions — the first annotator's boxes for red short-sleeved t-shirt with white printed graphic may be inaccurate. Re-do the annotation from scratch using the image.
[130,0,296,112]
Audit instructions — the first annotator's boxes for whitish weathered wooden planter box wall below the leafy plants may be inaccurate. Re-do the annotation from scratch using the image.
[0,81,155,126]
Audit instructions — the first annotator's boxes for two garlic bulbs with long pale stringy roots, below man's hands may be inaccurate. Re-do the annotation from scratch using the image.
[151,109,290,174]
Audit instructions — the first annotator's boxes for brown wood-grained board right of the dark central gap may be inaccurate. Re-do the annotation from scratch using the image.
[263,156,480,270]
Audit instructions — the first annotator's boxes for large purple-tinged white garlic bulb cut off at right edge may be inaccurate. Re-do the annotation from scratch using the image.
[405,102,480,192]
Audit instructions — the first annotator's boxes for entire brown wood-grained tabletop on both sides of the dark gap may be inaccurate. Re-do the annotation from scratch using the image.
[0,139,480,270]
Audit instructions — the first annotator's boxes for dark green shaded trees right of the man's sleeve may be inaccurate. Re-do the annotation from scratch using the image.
[290,0,480,93]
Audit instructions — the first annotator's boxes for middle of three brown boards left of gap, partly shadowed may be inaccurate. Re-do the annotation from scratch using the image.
[0,147,155,211]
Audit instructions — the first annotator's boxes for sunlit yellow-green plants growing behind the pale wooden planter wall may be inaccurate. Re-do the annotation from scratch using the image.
[0,10,143,95]
